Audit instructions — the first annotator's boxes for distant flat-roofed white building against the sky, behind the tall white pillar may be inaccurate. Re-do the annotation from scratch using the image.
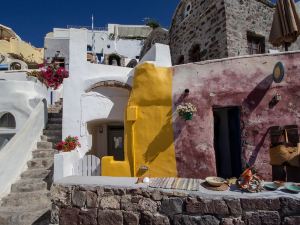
[44,24,152,67]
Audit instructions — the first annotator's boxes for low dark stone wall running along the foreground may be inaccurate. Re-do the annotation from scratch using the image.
[51,185,300,225]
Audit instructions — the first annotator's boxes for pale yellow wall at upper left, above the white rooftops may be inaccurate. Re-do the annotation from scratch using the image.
[0,38,44,63]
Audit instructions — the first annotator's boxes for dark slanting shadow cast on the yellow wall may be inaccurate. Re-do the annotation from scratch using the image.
[143,110,173,162]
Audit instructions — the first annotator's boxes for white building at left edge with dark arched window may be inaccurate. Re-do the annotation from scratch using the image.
[0,70,49,151]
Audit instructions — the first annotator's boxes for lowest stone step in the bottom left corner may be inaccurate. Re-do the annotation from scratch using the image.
[0,207,51,225]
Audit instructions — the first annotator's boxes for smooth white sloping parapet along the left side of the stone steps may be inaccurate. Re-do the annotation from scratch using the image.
[0,101,47,198]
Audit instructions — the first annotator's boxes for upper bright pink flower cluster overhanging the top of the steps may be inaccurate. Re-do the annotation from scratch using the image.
[39,62,69,90]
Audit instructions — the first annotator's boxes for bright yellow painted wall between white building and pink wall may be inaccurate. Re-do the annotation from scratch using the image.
[102,63,177,177]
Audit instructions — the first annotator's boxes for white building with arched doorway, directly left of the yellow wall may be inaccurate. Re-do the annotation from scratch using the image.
[54,29,171,180]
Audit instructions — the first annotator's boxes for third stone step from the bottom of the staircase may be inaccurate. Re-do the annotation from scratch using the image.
[11,178,47,193]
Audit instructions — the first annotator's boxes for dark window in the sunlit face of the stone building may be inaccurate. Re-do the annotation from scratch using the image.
[247,32,265,55]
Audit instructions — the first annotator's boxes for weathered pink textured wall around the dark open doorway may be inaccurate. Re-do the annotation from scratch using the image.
[173,52,300,179]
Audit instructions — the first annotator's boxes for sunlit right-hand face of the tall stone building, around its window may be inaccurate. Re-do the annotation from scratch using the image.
[225,0,275,56]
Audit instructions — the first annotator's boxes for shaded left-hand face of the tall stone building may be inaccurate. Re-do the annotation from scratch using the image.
[169,0,228,65]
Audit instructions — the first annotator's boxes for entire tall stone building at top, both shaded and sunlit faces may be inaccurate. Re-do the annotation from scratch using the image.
[169,0,300,65]
